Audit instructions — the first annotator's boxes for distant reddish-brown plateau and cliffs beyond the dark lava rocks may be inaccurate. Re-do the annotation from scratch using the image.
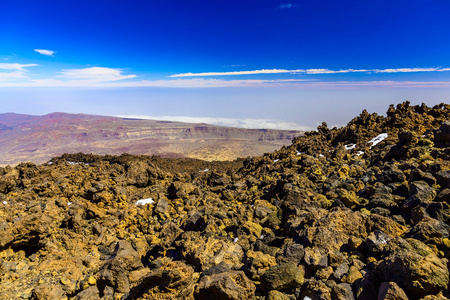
[0,113,302,165]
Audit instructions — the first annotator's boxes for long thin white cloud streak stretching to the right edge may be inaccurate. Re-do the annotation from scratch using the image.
[170,67,450,78]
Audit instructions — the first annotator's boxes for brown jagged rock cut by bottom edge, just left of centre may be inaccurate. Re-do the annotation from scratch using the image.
[195,271,256,300]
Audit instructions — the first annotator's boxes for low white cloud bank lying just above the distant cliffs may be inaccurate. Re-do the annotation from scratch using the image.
[117,115,313,131]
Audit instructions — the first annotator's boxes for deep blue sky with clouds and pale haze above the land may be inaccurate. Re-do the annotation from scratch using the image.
[0,0,450,129]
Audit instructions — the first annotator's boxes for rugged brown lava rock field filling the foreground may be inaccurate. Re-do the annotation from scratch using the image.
[0,102,450,300]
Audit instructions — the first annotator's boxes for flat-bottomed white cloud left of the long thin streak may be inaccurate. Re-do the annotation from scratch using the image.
[61,67,137,82]
